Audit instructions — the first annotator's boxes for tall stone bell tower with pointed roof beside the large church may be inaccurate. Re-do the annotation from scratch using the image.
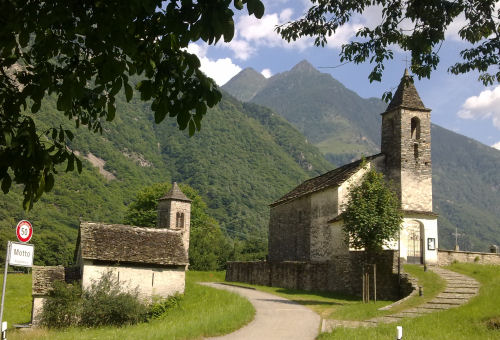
[381,70,432,212]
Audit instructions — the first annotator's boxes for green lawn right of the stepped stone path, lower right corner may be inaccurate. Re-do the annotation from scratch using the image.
[319,263,500,340]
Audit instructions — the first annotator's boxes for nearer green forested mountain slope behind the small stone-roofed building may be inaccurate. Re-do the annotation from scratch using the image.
[0,89,331,265]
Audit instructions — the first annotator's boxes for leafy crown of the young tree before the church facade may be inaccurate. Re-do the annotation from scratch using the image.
[342,168,403,254]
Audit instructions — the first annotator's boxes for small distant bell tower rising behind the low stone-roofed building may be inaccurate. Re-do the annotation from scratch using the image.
[156,182,191,252]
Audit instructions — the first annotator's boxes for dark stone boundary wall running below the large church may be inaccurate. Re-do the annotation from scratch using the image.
[226,250,411,299]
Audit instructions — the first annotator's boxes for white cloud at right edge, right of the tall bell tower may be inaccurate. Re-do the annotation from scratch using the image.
[457,85,500,130]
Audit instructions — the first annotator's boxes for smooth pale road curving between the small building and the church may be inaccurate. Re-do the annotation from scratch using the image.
[202,283,320,340]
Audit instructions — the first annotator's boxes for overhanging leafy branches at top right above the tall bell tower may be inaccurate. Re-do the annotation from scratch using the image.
[277,0,500,89]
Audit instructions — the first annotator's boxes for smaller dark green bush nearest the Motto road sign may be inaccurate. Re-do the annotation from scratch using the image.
[40,281,82,328]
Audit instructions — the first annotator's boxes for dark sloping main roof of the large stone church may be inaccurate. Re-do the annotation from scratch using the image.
[270,153,382,207]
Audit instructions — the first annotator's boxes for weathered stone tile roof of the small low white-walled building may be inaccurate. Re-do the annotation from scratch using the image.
[77,222,188,265]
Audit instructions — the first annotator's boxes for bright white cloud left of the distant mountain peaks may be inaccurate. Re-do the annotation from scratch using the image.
[187,43,241,86]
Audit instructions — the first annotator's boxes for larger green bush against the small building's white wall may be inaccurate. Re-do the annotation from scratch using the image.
[80,272,147,327]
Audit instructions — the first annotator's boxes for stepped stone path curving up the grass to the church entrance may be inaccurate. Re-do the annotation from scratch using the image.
[321,267,479,332]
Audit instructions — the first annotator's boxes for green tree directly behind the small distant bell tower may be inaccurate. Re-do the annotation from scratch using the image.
[125,183,232,270]
